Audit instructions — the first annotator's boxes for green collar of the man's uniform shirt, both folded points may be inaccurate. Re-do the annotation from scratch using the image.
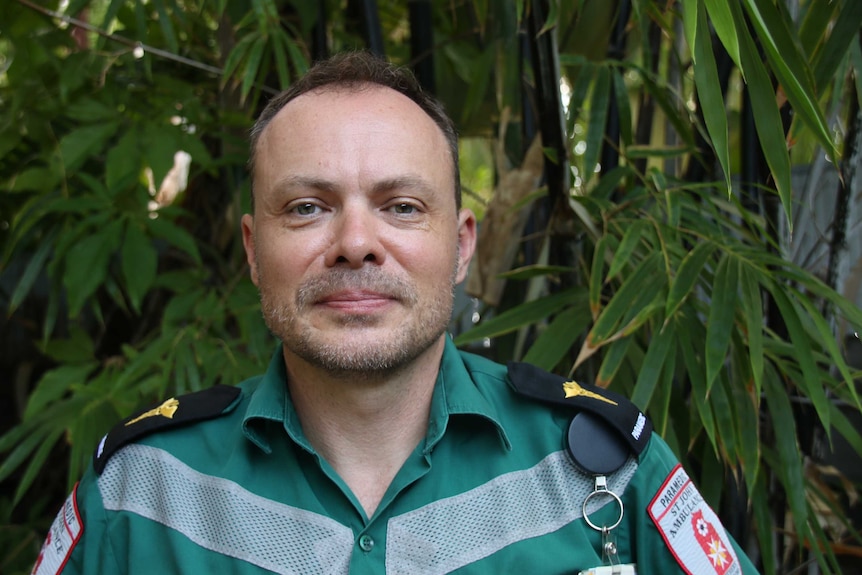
[242,337,512,454]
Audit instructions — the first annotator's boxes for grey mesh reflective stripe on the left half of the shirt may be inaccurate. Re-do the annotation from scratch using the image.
[99,445,353,575]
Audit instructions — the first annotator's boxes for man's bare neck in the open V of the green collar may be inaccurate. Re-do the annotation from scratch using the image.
[284,336,445,517]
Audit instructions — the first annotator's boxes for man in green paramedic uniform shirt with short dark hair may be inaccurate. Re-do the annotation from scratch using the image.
[36,54,754,574]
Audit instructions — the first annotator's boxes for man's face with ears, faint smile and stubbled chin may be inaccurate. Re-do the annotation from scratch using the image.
[242,86,476,375]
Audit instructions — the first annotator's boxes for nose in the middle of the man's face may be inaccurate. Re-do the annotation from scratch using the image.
[325,206,386,269]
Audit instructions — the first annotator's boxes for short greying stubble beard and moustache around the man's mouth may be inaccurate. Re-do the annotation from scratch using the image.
[258,266,457,379]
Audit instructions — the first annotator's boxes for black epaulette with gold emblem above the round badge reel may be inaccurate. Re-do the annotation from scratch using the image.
[508,362,652,455]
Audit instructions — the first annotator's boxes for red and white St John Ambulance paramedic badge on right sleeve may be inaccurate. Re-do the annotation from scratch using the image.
[649,465,742,575]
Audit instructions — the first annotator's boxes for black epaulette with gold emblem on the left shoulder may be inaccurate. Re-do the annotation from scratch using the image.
[93,385,241,475]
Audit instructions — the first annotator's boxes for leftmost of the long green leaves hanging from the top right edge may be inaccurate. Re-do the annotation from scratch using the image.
[693,0,736,196]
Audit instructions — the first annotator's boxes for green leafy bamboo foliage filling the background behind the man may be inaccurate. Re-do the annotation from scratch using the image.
[5,0,862,573]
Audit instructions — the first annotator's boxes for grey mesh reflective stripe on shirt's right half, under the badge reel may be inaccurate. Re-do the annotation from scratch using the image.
[386,451,637,575]
